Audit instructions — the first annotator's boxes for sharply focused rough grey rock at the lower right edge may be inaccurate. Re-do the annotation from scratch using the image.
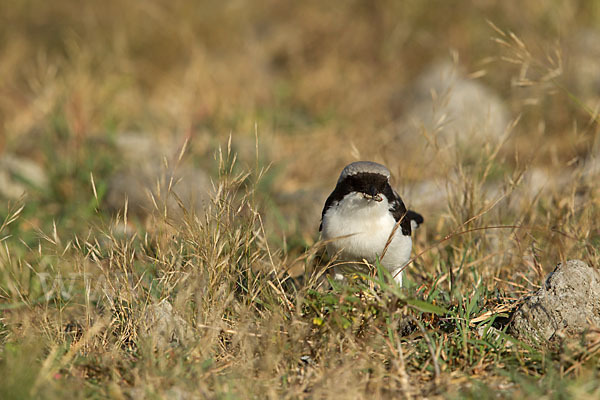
[509,260,600,343]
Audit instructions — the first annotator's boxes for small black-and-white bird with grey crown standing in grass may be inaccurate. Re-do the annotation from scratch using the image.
[319,161,424,286]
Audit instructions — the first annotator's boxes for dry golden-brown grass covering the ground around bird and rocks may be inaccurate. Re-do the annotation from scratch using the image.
[0,0,600,399]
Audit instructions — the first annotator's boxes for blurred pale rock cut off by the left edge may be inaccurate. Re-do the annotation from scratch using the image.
[0,154,48,200]
